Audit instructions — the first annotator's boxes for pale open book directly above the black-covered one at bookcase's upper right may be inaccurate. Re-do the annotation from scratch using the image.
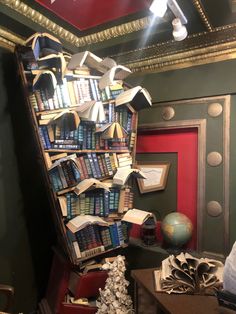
[98,65,132,90]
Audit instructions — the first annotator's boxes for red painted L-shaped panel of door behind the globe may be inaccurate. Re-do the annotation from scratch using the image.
[134,128,198,248]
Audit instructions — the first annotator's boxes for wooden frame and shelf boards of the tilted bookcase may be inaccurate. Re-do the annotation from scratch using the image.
[15,47,138,265]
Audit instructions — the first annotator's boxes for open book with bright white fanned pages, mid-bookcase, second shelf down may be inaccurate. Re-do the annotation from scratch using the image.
[76,100,106,122]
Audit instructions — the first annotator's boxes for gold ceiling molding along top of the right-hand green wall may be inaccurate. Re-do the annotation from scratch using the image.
[118,24,236,73]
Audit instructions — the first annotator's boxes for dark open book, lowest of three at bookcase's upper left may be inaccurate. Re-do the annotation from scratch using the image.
[32,70,57,98]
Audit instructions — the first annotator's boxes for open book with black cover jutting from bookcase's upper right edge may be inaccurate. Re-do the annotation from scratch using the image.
[115,86,152,111]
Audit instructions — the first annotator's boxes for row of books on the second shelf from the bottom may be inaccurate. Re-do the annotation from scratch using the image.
[60,187,133,219]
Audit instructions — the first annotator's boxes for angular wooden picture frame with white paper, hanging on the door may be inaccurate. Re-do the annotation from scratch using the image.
[136,161,170,194]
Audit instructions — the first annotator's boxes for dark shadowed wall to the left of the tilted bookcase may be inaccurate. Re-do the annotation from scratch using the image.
[0,48,54,313]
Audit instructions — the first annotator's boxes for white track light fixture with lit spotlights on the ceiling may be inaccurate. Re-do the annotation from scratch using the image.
[149,0,188,41]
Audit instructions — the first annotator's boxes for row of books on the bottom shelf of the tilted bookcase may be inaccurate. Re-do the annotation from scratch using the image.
[67,221,128,258]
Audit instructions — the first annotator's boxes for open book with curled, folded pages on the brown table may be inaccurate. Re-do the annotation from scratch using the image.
[154,253,224,295]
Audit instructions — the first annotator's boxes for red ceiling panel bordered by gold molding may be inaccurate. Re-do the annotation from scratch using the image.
[36,0,151,30]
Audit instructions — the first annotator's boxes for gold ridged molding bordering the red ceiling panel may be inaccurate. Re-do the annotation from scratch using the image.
[0,0,157,47]
